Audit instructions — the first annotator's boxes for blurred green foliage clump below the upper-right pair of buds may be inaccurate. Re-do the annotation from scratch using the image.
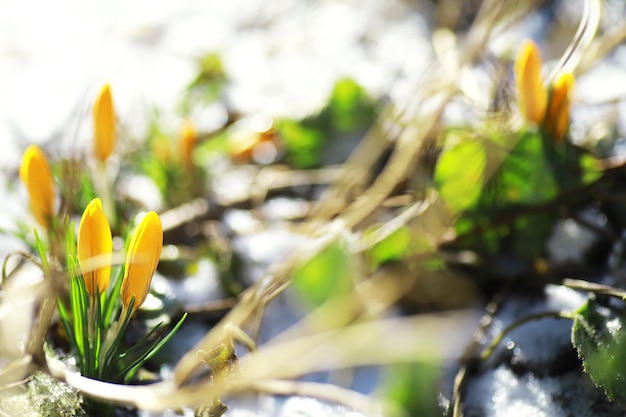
[434,128,602,275]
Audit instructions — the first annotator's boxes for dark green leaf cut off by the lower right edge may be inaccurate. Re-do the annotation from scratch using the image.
[572,300,626,406]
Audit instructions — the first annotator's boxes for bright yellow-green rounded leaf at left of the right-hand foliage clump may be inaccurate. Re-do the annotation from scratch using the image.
[435,132,487,212]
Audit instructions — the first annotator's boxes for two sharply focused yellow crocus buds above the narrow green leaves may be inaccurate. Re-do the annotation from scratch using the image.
[77,198,163,311]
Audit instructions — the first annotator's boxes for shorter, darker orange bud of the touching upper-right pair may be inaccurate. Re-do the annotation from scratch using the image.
[543,73,574,141]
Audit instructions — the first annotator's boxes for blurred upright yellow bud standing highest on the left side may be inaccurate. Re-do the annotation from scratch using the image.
[93,84,117,164]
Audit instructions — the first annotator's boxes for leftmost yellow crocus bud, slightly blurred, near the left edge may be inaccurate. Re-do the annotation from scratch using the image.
[20,145,54,229]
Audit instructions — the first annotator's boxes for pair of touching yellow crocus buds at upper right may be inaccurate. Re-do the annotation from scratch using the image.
[514,40,574,141]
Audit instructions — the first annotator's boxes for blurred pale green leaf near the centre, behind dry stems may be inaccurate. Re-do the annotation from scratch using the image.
[293,242,355,308]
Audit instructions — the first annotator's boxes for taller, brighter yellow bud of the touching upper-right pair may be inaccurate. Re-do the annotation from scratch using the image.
[514,40,548,124]
